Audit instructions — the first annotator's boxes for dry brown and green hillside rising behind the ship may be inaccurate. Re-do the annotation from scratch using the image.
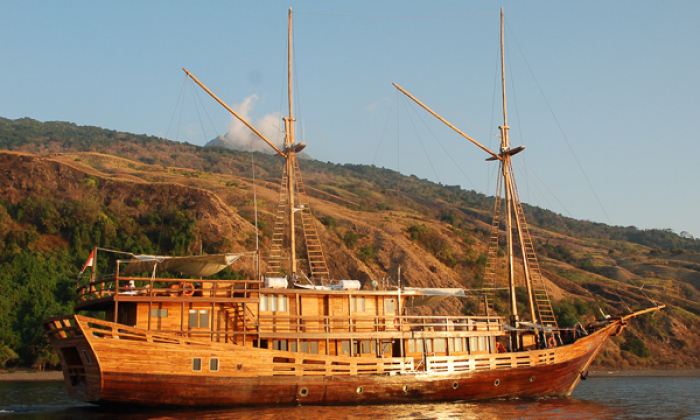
[0,119,700,369]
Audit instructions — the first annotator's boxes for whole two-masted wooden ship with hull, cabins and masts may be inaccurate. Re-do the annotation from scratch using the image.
[43,9,663,406]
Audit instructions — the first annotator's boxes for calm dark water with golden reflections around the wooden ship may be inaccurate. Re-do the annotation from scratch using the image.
[0,378,700,420]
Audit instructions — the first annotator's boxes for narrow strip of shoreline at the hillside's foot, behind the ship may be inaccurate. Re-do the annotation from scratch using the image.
[0,369,700,382]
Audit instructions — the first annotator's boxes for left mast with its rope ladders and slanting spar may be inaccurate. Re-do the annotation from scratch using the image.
[182,7,329,283]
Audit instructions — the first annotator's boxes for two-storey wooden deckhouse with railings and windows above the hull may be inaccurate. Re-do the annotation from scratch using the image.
[76,249,507,364]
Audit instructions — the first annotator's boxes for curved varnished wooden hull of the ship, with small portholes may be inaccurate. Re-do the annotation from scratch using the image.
[45,316,621,406]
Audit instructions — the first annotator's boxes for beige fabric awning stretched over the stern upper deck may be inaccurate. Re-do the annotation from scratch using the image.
[119,254,243,277]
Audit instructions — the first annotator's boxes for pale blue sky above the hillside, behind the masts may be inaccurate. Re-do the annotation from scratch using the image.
[0,0,700,236]
